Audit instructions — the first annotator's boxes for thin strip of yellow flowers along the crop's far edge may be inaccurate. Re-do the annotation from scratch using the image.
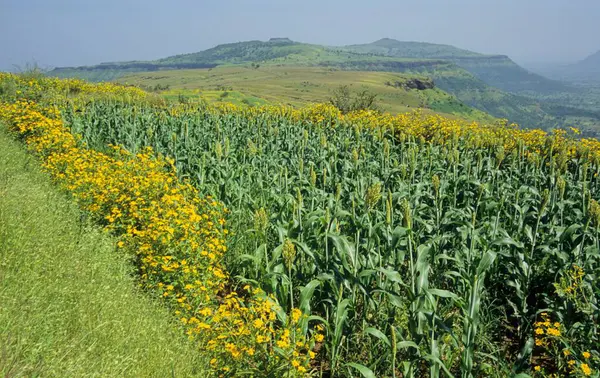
[119,94,600,162]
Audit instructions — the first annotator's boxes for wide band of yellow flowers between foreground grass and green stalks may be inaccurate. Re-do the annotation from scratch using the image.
[0,97,315,376]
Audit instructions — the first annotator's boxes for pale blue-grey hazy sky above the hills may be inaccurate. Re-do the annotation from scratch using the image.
[0,0,600,69]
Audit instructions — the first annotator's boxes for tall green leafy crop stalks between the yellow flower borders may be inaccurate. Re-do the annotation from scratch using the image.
[64,101,600,378]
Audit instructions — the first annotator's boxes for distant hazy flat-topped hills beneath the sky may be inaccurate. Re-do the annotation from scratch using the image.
[50,38,600,134]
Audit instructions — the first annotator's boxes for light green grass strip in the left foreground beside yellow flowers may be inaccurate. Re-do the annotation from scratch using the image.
[0,128,206,377]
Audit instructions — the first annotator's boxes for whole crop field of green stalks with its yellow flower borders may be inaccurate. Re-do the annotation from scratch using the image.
[0,75,600,377]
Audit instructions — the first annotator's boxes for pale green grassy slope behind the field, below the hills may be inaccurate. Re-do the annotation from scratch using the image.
[118,66,492,121]
